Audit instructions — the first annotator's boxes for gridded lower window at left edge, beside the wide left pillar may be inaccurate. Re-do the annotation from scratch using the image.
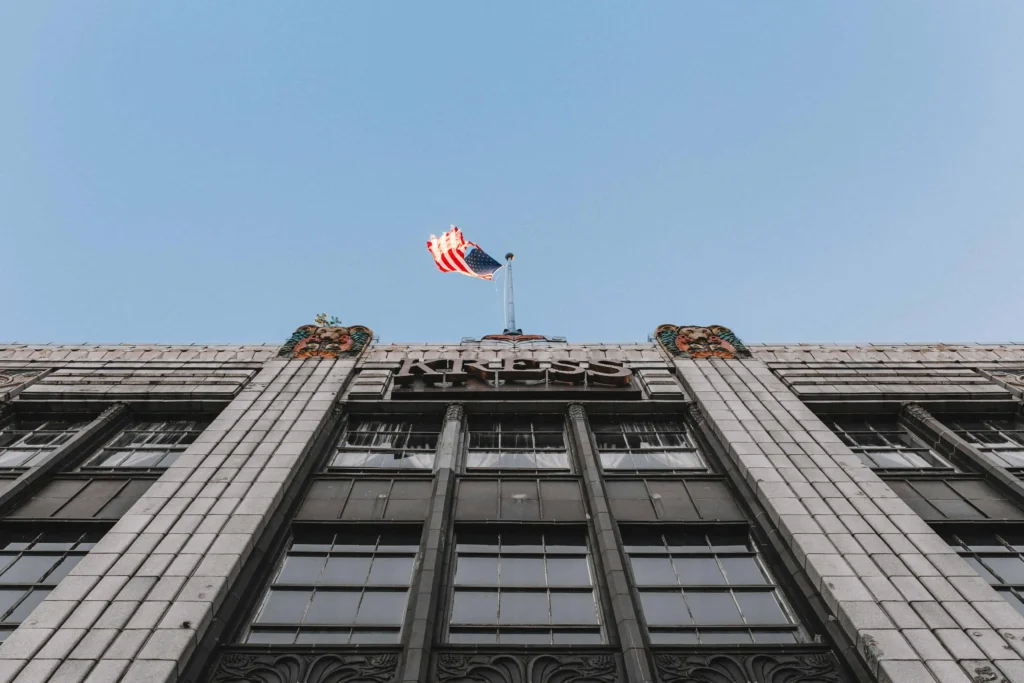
[0,531,102,640]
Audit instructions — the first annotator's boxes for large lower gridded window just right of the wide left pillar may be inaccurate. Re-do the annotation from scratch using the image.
[245,528,420,645]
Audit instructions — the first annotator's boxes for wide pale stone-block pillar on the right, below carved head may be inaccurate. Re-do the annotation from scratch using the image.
[674,359,1024,683]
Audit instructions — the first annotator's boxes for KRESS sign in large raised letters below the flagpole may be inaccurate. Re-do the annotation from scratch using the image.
[393,357,638,397]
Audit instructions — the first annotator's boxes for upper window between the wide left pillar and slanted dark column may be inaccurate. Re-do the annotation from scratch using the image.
[82,420,210,469]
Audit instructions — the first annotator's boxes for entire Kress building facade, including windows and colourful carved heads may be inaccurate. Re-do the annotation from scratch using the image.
[0,325,1024,683]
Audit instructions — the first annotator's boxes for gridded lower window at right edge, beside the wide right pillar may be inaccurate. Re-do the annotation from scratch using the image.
[944,532,1024,614]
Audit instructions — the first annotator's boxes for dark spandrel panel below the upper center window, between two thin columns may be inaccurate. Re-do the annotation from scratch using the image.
[455,477,587,522]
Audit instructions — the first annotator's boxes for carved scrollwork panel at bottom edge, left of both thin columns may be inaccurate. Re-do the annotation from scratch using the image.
[210,652,398,683]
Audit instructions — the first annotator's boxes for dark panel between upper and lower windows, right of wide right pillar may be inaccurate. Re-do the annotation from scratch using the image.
[886,478,1024,521]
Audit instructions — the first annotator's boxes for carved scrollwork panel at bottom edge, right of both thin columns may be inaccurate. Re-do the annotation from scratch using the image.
[654,652,843,683]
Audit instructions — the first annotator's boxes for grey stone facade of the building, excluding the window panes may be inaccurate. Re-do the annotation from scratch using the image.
[0,337,1024,683]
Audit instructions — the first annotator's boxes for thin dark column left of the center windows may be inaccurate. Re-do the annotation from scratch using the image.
[394,403,466,683]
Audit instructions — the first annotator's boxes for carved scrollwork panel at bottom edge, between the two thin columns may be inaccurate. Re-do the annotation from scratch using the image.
[432,653,623,683]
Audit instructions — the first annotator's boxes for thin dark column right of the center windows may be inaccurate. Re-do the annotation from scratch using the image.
[568,403,655,683]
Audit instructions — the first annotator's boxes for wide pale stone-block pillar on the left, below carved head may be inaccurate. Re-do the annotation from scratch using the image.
[0,359,355,683]
